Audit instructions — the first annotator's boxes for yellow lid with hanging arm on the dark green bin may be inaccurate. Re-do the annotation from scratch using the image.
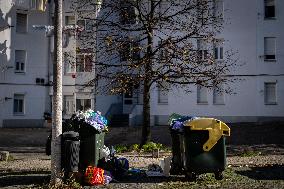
[184,118,230,152]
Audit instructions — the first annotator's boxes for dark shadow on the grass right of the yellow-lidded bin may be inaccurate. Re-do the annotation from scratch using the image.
[236,165,284,180]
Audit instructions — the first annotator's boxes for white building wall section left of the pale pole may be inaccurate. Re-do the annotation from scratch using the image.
[0,1,49,127]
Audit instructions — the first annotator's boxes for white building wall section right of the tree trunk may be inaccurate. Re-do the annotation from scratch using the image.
[151,0,284,125]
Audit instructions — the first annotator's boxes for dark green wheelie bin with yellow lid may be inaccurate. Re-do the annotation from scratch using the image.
[183,118,230,180]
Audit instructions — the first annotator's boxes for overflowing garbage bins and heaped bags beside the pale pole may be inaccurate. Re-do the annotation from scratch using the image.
[51,109,133,185]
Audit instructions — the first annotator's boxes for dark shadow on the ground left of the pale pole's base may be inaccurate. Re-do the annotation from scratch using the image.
[0,171,50,188]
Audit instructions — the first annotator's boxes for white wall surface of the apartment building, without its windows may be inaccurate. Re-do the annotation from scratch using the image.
[0,0,284,127]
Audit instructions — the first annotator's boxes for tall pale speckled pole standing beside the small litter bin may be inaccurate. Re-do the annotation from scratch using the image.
[50,0,62,185]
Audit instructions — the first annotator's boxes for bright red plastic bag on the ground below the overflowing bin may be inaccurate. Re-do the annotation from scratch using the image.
[84,166,105,185]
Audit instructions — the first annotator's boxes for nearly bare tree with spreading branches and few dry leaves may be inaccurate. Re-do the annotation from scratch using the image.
[71,0,236,145]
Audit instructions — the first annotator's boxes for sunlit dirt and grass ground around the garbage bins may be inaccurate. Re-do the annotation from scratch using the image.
[0,151,284,189]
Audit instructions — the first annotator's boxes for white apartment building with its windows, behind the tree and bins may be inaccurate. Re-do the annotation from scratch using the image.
[0,0,284,127]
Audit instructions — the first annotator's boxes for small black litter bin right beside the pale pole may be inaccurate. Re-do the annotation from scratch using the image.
[61,131,80,175]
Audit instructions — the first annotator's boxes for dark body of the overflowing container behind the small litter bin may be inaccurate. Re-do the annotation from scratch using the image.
[79,124,105,172]
